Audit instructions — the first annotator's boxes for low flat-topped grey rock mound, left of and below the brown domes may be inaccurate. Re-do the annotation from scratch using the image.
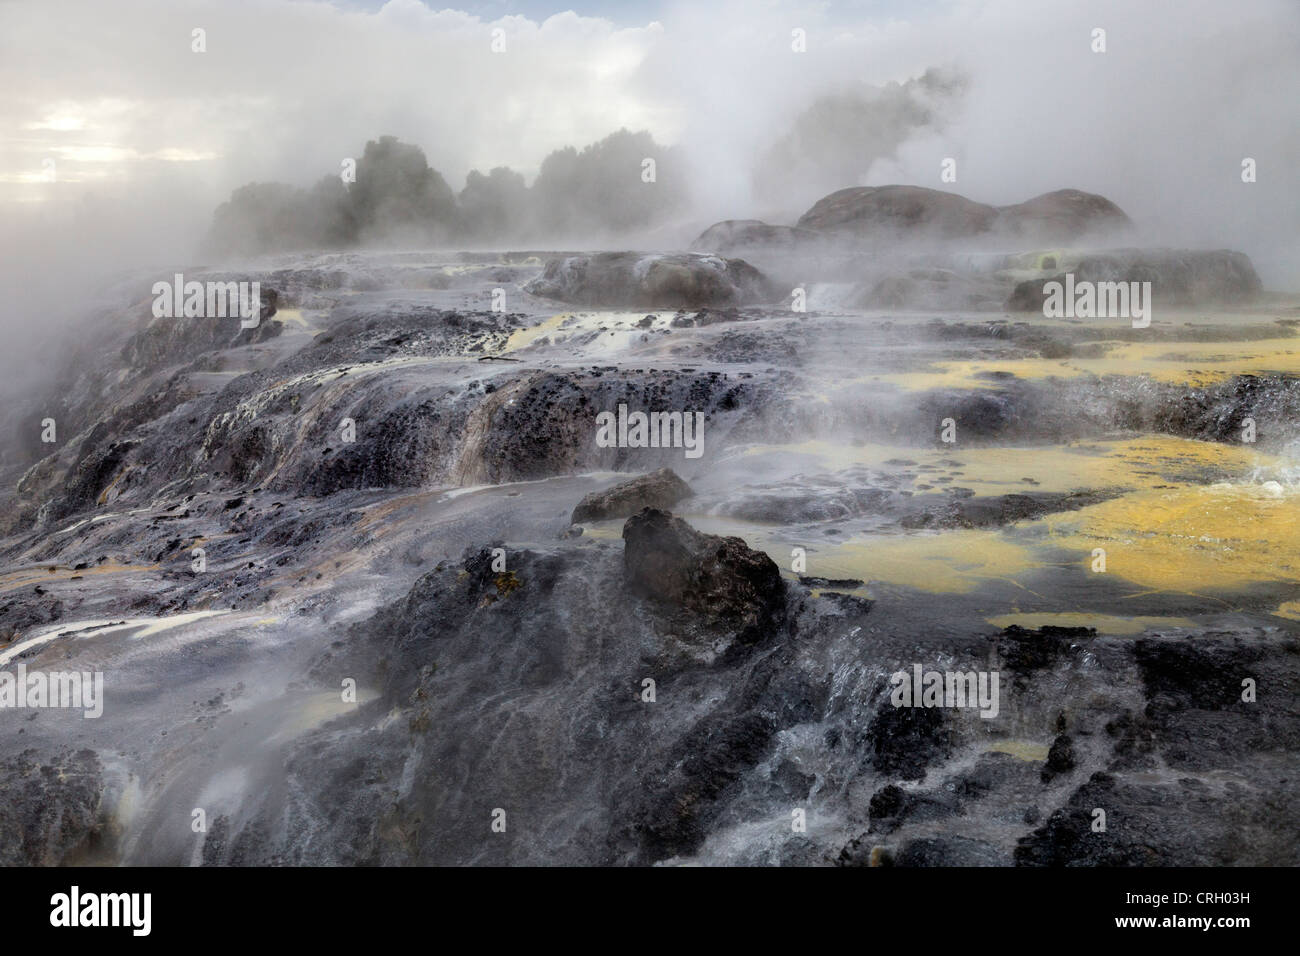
[524,252,772,308]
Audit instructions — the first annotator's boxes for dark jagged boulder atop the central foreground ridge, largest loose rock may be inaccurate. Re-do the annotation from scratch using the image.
[623,509,785,643]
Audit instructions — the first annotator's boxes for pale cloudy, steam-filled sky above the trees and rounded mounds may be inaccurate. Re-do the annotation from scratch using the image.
[0,0,1300,282]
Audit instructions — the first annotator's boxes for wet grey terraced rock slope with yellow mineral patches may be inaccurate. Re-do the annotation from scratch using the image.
[0,248,1300,866]
